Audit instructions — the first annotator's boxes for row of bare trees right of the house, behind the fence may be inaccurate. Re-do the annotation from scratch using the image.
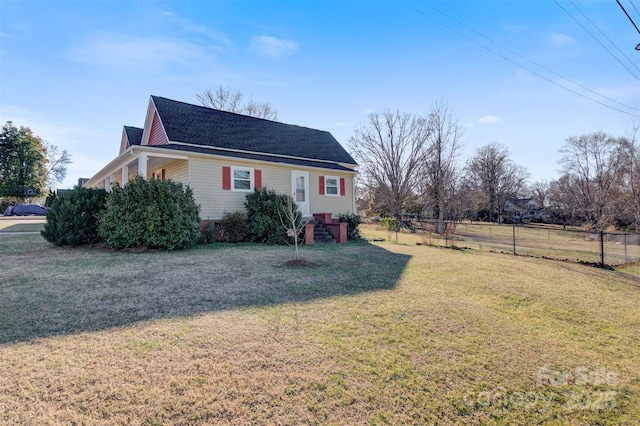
[350,102,640,231]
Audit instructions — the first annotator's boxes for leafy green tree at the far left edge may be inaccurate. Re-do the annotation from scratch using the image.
[0,121,48,198]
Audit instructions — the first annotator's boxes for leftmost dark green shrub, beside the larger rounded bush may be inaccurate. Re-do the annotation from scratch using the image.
[41,187,106,246]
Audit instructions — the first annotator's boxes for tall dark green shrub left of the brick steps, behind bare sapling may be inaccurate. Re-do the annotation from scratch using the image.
[244,189,289,244]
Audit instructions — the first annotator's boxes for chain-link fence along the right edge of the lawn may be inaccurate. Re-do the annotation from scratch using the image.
[400,219,640,267]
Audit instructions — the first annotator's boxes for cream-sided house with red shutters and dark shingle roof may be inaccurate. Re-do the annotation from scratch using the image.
[84,96,357,240]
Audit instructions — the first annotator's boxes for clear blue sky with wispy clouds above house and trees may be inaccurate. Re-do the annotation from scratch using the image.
[0,0,640,188]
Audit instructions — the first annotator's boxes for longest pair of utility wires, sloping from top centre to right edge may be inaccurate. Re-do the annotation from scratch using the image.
[417,1,640,118]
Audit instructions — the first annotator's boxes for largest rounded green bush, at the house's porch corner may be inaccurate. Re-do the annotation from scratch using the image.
[98,176,200,250]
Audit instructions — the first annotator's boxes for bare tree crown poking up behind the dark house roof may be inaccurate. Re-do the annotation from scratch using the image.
[196,85,278,121]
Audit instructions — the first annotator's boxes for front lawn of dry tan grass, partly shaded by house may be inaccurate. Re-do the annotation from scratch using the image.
[0,230,640,425]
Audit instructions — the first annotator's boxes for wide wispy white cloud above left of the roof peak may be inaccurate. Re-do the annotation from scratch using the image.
[69,35,207,70]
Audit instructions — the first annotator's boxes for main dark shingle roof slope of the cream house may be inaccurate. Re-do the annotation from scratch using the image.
[151,96,357,165]
